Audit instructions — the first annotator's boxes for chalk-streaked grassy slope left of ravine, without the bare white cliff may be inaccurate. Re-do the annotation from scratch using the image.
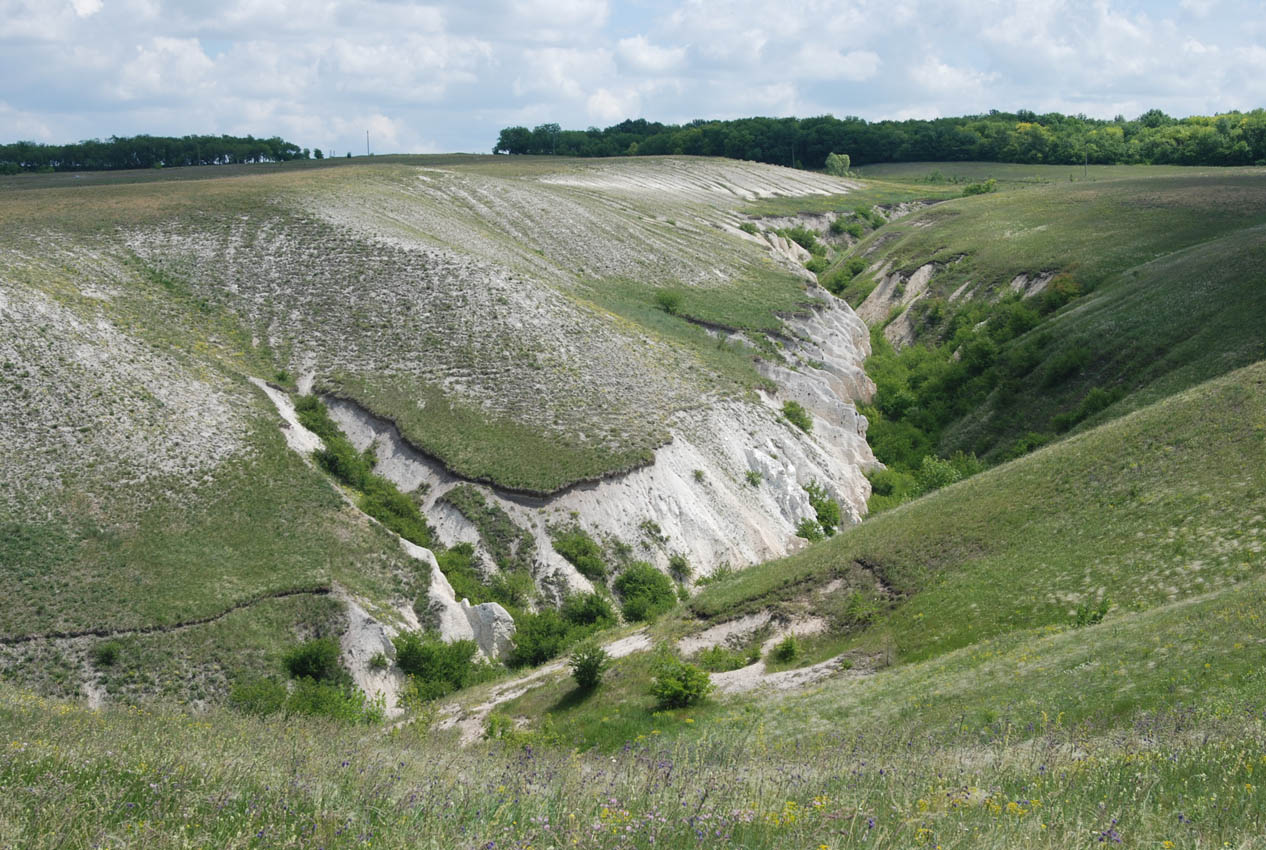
[0,156,871,702]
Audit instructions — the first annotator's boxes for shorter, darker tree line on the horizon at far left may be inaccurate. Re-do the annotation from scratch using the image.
[0,136,322,174]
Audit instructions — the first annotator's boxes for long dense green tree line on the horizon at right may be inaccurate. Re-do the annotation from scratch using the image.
[492,109,1266,168]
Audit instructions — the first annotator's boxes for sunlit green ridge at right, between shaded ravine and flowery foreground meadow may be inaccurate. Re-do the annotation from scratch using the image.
[690,364,1266,659]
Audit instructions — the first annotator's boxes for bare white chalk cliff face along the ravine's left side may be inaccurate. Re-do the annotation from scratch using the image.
[327,282,875,589]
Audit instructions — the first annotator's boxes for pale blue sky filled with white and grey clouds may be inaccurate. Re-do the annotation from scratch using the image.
[0,0,1266,156]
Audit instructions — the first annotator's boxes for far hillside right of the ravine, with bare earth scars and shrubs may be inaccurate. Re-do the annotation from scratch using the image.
[825,163,1266,496]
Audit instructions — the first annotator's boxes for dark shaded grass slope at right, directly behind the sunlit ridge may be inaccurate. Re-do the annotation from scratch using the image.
[944,221,1266,454]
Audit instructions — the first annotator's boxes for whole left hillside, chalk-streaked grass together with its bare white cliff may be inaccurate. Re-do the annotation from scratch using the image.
[0,158,871,695]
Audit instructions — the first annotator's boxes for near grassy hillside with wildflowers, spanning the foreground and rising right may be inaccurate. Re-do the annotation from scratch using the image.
[0,365,1266,850]
